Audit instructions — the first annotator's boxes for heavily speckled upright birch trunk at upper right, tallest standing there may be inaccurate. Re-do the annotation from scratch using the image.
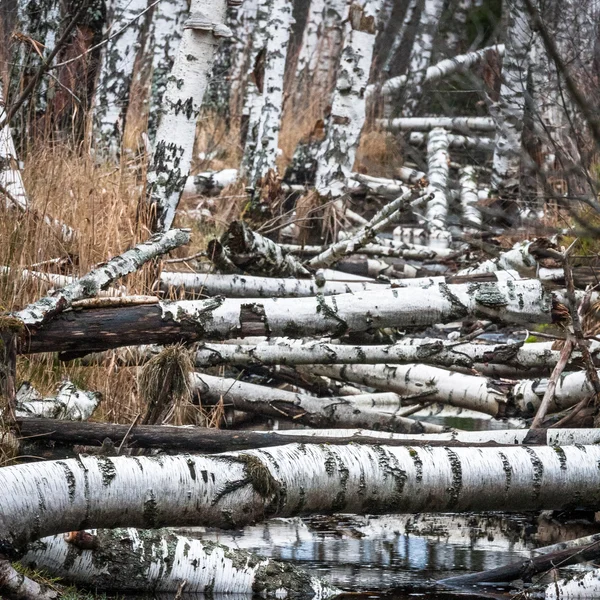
[492,0,532,192]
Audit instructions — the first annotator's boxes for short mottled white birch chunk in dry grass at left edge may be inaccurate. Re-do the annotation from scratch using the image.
[16,381,102,421]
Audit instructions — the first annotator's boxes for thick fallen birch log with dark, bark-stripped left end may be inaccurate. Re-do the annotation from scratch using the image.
[20,280,565,354]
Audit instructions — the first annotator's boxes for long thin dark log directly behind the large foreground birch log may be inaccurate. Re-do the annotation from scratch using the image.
[17,418,564,452]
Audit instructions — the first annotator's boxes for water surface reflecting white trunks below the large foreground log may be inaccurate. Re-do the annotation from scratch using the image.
[118,513,598,600]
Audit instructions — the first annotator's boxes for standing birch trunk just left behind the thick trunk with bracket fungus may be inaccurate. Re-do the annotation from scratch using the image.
[148,0,188,141]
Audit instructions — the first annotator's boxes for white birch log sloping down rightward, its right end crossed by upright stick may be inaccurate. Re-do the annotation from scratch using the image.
[310,364,594,418]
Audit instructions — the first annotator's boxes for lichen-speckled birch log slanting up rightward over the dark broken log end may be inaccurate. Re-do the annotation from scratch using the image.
[14,229,190,326]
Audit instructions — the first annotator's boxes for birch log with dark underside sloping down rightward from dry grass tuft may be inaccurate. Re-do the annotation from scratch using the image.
[190,373,443,433]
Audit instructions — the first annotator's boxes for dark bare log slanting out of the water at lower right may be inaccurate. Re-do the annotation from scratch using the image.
[439,542,600,587]
